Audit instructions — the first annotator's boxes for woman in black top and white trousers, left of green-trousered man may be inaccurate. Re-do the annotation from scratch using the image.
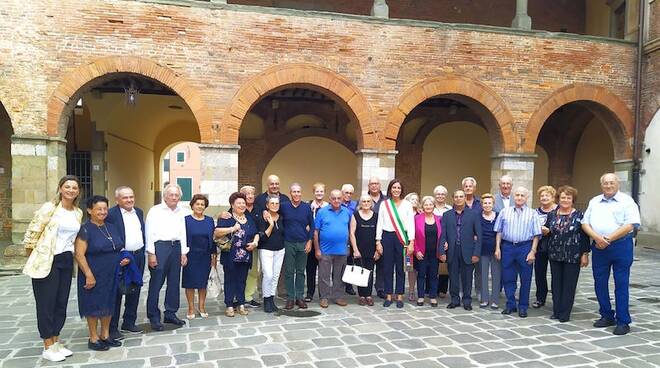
[259,196,284,313]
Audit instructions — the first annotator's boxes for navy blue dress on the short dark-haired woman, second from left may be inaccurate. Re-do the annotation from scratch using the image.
[78,221,124,317]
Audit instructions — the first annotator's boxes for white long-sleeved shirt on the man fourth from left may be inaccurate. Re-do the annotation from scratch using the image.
[145,203,190,254]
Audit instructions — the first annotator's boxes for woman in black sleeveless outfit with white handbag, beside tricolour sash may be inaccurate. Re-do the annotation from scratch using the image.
[349,193,380,306]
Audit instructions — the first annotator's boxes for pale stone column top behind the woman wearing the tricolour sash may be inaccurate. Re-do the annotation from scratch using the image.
[355,149,398,197]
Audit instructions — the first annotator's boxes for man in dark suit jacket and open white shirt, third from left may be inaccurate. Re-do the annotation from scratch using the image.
[106,186,146,338]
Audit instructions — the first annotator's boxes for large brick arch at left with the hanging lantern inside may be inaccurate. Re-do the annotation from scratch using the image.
[46,56,213,143]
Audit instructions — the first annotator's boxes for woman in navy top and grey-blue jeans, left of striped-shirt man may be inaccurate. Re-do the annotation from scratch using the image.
[479,193,502,309]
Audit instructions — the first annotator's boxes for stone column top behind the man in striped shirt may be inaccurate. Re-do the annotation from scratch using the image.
[490,153,537,200]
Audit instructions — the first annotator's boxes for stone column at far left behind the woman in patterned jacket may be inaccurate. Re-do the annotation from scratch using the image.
[11,135,66,244]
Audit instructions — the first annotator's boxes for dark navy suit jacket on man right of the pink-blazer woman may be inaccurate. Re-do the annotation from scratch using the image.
[438,207,481,264]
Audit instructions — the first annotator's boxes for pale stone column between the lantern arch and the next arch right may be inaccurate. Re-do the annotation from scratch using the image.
[199,144,241,215]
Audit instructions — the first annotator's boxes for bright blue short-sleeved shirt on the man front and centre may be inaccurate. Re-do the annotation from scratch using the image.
[315,206,352,255]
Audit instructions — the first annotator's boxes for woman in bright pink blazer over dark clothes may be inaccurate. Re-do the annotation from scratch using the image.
[408,196,442,307]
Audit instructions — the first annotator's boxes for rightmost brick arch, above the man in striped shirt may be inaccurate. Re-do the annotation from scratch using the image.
[522,83,635,160]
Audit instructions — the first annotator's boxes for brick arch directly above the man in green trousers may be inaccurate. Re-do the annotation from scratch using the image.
[220,64,378,148]
